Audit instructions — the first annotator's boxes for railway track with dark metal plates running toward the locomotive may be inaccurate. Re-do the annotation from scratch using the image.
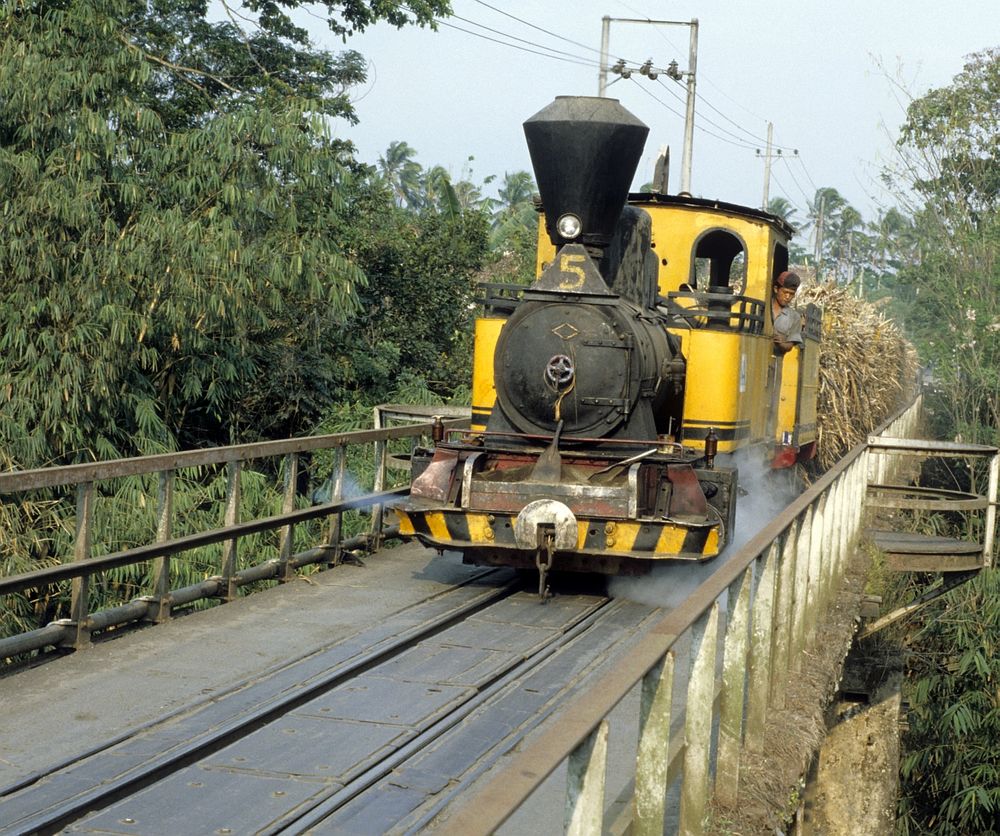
[0,572,656,834]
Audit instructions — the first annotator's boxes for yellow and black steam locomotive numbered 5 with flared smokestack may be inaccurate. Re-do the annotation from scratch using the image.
[396,97,820,590]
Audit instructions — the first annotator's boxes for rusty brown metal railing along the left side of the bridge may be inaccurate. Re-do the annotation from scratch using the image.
[0,420,468,661]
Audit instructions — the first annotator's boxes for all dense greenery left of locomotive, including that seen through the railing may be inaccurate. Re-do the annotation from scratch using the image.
[0,0,533,630]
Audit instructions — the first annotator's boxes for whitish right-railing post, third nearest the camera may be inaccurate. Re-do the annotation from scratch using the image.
[679,601,719,836]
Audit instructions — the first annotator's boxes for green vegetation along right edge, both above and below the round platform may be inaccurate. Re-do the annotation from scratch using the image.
[876,49,1000,836]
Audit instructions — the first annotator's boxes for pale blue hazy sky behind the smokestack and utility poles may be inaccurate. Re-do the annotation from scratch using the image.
[303,0,1000,227]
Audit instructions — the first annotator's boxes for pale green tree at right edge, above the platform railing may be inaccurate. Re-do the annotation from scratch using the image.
[896,49,1000,444]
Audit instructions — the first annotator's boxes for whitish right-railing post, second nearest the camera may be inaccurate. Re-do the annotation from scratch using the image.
[631,651,674,836]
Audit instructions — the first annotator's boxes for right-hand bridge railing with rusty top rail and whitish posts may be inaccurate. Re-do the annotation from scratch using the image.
[437,398,920,836]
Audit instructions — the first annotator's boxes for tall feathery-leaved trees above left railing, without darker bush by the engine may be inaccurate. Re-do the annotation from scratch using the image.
[0,0,447,466]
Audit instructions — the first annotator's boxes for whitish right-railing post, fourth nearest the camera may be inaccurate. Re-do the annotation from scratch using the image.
[715,566,753,807]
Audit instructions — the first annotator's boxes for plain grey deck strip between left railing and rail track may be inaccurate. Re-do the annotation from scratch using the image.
[0,544,483,792]
